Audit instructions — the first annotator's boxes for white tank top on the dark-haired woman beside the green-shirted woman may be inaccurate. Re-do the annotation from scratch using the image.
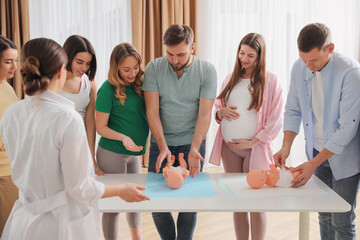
[59,74,91,119]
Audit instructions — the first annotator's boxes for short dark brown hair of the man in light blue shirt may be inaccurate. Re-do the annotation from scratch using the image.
[297,23,331,53]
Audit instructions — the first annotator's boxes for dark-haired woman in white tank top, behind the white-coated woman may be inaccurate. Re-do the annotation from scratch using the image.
[59,35,105,175]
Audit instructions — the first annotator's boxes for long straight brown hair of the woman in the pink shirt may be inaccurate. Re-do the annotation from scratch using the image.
[217,33,266,111]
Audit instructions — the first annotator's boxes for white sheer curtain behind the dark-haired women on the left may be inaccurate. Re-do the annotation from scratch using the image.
[29,0,131,88]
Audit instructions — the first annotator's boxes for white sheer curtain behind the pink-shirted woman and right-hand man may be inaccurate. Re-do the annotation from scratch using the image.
[197,0,360,165]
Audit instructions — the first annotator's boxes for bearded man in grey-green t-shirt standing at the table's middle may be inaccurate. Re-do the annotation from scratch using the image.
[143,25,216,240]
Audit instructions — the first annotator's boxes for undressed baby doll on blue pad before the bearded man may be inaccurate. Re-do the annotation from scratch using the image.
[163,153,189,189]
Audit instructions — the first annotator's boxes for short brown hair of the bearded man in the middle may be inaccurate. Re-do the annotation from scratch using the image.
[163,24,194,46]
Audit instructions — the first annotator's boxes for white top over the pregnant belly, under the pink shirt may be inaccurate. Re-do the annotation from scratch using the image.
[221,79,257,142]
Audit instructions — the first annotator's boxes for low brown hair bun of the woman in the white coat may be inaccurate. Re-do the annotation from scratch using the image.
[21,56,50,96]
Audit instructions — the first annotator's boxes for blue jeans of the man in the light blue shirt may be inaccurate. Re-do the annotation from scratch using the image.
[314,149,360,240]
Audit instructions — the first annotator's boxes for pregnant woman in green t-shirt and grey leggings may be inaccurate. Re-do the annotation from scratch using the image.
[95,43,149,239]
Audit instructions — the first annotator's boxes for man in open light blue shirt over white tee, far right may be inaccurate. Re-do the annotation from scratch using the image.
[274,23,360,240]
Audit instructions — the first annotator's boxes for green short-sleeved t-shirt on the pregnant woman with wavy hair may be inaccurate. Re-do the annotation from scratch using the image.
[95,80,149,155]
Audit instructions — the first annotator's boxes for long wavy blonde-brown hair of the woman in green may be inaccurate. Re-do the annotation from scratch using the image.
[108,43,144,104]
